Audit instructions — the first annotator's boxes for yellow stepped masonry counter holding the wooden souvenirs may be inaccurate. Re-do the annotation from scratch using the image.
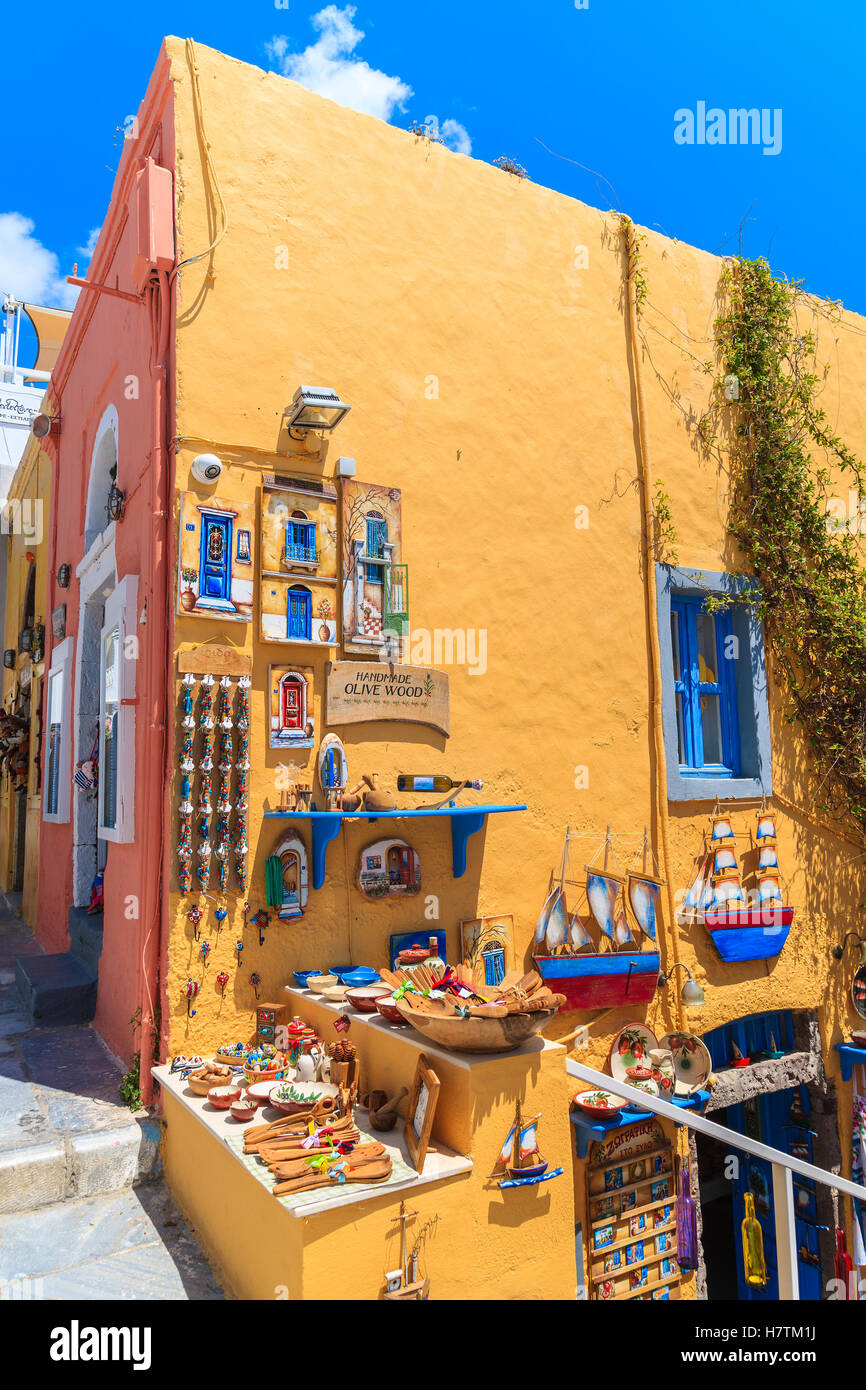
[153,988,577,1301]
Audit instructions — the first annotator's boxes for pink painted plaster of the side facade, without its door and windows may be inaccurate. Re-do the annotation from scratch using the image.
[36,50,175,1058]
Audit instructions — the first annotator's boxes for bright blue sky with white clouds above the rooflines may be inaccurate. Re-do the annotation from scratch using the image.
[0,0,866,355]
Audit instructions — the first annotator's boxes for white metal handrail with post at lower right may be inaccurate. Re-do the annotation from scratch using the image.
[566,1058,866,1302]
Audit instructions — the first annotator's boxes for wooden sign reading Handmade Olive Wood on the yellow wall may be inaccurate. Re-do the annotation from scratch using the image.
[328,662,450,737]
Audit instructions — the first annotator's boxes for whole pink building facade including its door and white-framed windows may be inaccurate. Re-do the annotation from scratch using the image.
[36,50,175,1073]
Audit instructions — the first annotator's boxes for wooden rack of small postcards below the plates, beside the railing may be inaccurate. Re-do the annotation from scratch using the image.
[587,1119,680,1302]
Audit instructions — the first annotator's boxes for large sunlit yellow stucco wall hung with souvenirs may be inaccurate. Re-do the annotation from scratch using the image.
[159,40,866,1295]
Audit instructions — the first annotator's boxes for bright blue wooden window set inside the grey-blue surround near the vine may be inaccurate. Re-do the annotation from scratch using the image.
[670,596,740,778]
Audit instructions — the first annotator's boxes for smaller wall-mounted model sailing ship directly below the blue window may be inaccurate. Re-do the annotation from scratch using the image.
[681,808,794,960]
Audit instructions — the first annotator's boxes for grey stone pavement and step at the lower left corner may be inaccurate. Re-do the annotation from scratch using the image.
[0,913,224,1300]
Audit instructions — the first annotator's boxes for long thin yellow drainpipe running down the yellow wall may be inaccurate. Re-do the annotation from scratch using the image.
[621,217,687,1031]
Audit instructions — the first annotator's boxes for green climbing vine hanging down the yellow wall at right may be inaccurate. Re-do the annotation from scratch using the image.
[702,257,866,833]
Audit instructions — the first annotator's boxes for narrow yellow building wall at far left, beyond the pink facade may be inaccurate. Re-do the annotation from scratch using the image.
[0,436,51,926]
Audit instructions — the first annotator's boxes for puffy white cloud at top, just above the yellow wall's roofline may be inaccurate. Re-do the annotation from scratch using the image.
[265,4,413,121]
